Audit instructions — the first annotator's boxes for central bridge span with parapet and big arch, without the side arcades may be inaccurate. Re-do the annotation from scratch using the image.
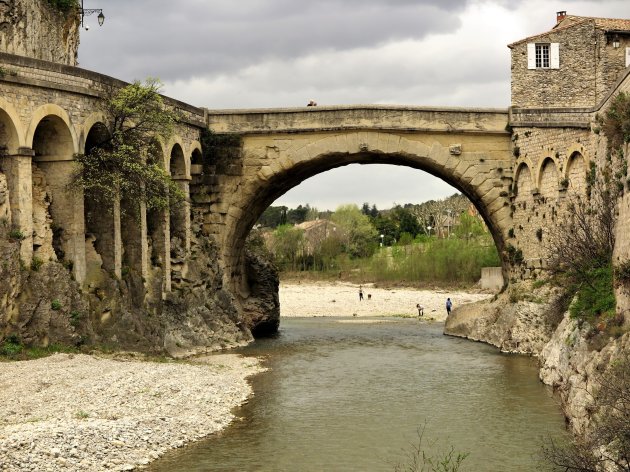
[204,105,515,297]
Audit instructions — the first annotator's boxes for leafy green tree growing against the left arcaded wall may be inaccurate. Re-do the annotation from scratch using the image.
[74,79,183,213]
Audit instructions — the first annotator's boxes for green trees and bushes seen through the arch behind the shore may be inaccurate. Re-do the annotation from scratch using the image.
[250,194,500,283]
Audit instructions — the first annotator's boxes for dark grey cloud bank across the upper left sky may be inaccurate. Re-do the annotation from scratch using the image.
[80,0,470,80]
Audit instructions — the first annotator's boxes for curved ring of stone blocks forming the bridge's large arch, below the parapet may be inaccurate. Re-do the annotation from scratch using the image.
[214,131,511,297]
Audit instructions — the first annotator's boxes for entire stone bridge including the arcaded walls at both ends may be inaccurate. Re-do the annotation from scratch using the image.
[0,47,608,342]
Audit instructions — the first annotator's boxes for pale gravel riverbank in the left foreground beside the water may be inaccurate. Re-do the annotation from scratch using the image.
[0,354,262,472]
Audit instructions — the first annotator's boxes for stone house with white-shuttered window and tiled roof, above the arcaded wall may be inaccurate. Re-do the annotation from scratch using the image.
[508,12,630,107]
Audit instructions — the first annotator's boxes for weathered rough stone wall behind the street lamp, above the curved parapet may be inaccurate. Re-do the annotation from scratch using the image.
[0,0,80,65]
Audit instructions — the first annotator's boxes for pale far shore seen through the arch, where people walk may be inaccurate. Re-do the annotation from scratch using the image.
[280,282,492,321]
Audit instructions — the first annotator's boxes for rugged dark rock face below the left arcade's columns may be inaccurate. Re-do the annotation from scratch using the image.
[0,217,279,356]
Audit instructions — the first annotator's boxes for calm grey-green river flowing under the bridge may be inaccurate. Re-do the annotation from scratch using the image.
[149,318,565,472]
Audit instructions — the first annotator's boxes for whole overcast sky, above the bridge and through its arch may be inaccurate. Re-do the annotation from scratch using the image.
[79,0,630,210]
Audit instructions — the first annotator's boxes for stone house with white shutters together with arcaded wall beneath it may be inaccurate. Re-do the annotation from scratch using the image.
[508,12,630,278]
